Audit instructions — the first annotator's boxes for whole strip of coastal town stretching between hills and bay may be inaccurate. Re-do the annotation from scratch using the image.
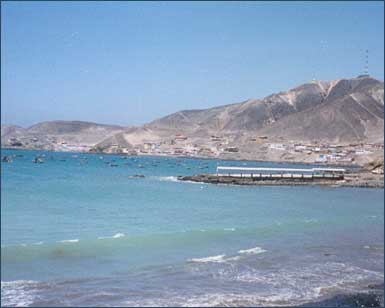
[5,134,384,173]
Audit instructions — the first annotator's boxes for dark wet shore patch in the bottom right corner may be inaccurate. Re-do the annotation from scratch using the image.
[299,292,384,307]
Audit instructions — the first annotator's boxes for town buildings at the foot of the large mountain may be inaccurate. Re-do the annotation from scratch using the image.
[97,135,384,164]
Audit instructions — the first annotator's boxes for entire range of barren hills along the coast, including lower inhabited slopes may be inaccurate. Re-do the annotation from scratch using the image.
[1,76,384,160]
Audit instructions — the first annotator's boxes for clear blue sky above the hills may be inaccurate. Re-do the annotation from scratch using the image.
[1,1,384,126]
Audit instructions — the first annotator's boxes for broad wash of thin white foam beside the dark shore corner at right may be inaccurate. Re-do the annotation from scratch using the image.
[180,263,383,307]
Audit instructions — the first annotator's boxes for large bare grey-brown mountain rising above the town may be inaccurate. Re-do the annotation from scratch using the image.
[101,76,384,144]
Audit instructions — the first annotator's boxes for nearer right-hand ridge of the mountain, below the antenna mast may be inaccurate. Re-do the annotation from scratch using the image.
[261,78,384,143]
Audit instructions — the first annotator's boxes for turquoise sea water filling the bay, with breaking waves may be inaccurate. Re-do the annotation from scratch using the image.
[1,150,384,306]
